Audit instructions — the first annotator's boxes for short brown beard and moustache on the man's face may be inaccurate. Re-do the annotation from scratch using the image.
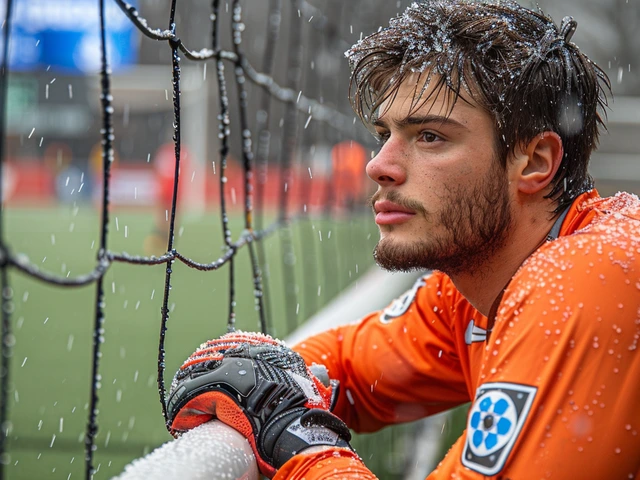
[371,159,513,276]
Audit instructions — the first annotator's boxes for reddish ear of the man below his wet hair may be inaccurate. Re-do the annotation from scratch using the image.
[514,132,564,194]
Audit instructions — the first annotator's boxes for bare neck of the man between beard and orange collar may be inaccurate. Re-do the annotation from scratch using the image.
[450,215,557,316]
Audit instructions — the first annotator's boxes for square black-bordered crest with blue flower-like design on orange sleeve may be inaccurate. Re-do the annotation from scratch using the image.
[462,382,537,475]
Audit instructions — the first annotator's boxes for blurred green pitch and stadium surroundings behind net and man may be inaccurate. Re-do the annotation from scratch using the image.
[0,0,640,479]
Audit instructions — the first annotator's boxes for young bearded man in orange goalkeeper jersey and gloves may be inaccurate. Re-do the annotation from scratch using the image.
[169,0,640,480]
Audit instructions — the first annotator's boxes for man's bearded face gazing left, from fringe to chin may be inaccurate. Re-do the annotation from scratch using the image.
[367,78,512,275]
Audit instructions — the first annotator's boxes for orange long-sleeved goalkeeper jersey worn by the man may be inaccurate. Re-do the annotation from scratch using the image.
[275,191,640,480]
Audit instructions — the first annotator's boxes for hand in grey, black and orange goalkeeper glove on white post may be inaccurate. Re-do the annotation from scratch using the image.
[167,332,351,478]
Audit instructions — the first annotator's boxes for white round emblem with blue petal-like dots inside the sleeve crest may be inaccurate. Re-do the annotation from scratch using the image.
[467,390,518,457]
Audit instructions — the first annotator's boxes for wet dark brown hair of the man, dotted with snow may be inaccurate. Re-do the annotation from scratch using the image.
[346,0,611,212]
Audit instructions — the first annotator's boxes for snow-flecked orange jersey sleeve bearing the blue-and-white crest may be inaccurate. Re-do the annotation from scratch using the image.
[429,235,640,480]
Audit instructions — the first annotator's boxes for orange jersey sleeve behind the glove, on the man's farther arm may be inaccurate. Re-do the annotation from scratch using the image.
[294,274,469,432]
